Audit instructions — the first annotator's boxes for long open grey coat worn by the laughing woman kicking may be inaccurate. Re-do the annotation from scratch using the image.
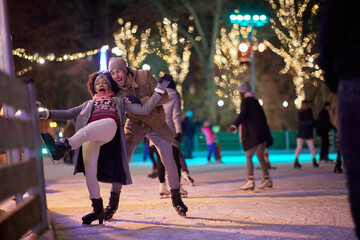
[46,93,161,185]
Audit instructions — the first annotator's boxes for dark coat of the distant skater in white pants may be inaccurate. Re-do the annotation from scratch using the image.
[297,108,315,139]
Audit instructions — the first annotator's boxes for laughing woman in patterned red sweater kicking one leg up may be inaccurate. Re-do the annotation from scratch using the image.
[39,72,169,224]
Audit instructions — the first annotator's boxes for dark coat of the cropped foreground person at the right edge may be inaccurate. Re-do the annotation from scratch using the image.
[317,0,360,93]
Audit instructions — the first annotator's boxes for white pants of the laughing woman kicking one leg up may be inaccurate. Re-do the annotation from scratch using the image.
[68,118,122,199]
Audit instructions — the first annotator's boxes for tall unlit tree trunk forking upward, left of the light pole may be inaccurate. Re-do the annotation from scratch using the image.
[151,0,224,123]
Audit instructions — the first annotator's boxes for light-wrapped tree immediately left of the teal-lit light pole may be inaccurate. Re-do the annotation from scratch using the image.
[214,24,247,113]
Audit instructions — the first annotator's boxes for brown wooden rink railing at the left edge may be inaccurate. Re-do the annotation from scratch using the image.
[0,71,50,240]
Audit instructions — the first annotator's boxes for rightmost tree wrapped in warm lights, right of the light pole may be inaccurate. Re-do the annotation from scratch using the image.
[265,0,323,108]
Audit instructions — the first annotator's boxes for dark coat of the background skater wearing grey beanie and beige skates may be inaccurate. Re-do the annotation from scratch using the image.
[233,97,273,151]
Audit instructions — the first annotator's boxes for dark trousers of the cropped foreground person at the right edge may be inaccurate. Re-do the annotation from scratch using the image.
[337,77,360,238]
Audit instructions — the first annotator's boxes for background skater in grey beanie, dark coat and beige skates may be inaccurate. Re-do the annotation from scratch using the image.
[228,82,273,190]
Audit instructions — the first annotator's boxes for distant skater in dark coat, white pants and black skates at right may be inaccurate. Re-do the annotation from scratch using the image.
[294,100,319,168]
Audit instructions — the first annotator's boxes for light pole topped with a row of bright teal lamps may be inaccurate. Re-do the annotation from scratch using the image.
[230,14,269,93]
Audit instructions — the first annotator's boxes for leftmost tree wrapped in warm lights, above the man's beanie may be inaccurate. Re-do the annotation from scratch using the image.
[114,18,153,68]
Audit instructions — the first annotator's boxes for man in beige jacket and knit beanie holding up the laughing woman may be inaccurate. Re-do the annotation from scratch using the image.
[109,57,188,216]
